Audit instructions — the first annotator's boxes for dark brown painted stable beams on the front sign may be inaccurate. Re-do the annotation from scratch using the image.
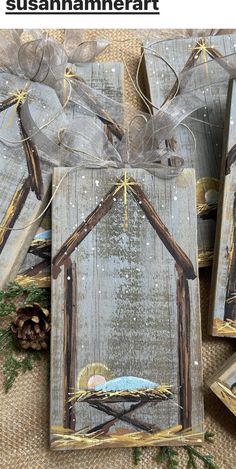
[52,175,196,442]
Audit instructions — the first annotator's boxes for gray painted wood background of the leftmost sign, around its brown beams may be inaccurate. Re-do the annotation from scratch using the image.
[0,73,64,288]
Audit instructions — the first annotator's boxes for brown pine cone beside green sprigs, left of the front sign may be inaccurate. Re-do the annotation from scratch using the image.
[11,303,50,350]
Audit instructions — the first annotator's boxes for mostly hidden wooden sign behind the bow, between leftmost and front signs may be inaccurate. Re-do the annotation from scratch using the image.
[17,62,124,288]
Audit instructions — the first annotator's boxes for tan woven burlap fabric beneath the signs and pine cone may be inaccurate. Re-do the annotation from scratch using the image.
[0,29,236,469]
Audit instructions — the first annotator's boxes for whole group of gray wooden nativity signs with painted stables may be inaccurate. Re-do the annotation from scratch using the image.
[0,30,236,450]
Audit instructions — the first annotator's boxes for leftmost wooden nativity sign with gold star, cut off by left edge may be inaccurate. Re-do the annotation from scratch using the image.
[0,73,64,288]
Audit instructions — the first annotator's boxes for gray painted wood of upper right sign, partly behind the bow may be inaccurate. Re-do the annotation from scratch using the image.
[144,34,236,267]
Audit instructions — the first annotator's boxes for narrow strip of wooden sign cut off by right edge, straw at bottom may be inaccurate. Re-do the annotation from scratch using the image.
[210,80,236,337]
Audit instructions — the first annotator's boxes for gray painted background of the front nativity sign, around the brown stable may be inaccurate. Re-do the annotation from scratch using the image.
[51,168,203,449]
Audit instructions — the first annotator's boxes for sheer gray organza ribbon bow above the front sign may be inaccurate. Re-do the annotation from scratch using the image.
[0,31,236,178]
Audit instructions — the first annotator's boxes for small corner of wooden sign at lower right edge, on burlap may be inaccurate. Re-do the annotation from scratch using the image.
[209,353,236,415]
